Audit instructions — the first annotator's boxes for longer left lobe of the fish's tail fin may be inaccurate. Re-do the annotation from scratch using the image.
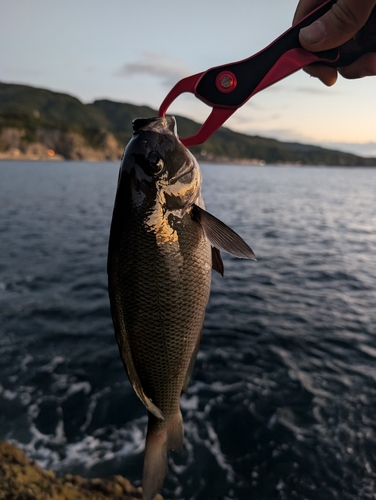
[142,412,167,500]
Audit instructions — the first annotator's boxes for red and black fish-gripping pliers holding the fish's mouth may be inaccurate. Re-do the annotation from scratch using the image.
[159,0,374,147]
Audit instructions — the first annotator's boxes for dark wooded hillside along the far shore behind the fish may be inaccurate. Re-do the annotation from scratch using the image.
[0,83,376,166]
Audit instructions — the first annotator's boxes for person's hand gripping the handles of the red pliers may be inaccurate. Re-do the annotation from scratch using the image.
[293,0,376,86]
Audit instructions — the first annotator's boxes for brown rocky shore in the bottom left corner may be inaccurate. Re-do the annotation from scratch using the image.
[0,441,163,500]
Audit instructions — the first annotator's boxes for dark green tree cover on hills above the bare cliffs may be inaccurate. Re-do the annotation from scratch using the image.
[0,83,376,166]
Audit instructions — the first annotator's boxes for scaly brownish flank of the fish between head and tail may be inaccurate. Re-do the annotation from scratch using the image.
[113,207,211,418]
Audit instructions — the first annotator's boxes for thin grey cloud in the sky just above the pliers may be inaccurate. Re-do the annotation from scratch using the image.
[116,51,190,87]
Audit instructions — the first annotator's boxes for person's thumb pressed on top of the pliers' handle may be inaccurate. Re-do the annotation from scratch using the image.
[299,0,376,51]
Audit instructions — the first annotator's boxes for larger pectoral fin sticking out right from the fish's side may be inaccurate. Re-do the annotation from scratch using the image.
[192,204,256,260]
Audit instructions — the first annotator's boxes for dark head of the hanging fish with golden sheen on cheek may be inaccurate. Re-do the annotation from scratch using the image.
[119,116,201,211]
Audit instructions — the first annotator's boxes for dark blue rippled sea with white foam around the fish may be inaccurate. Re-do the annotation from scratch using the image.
[0,161,376,500]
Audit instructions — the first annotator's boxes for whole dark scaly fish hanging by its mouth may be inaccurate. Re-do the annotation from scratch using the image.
[107,116,256,500]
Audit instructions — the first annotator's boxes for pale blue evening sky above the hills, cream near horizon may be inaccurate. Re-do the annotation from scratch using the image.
[0,0,376,156]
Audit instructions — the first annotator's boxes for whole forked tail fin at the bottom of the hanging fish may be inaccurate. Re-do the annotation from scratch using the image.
[142,410,183,500]
